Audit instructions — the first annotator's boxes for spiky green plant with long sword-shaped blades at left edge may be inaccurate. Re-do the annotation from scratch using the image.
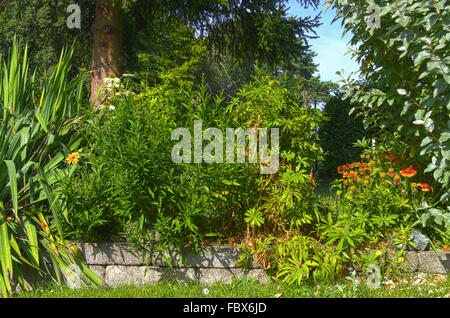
[0,39,101,297]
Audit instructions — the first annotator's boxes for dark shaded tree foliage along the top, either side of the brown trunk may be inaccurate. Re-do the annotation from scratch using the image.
[0,0,319,75]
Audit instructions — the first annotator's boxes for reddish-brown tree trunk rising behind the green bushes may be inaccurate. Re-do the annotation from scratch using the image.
[89,0,124,108]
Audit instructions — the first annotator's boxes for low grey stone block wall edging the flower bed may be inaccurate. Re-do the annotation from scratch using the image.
[79,243,450,286]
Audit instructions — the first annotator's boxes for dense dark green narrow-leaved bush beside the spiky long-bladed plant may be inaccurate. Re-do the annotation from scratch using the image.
[57,72,259,251]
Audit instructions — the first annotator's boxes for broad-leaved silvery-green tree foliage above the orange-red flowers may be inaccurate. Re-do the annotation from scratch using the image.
[329,0,450,209]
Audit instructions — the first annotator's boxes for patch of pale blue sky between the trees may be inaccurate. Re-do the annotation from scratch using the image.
[288,0,358,82]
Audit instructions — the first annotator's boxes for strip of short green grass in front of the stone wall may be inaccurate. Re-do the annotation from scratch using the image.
[15,274,450,298]
